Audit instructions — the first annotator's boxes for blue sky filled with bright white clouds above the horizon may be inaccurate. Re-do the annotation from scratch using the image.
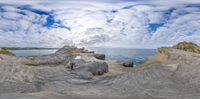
[0,0,200,48]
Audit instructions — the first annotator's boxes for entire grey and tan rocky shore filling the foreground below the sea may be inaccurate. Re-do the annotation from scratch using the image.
[0,42,200,99]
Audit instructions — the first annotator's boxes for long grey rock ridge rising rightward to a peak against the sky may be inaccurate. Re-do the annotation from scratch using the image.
[22,46,82,66]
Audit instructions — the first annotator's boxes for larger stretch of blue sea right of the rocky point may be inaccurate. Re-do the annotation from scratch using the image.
[90,47,156,66]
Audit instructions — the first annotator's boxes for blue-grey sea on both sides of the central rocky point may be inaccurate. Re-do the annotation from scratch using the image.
[11,47,156,66]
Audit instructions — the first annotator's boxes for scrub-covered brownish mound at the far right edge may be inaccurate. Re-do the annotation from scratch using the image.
[173,42,200,54]
